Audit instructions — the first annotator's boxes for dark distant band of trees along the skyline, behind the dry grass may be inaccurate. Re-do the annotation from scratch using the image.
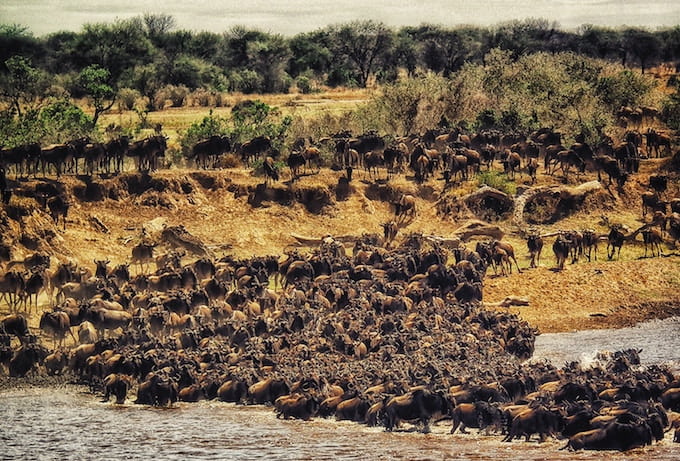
[0,14,680,96]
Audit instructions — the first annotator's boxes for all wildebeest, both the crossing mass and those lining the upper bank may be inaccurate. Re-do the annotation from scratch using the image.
[0,123,680,450]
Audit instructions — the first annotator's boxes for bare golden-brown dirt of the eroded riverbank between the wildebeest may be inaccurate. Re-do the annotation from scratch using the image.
[0,156,680,332]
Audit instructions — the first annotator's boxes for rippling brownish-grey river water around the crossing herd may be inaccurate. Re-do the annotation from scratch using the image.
[0,318,680,461]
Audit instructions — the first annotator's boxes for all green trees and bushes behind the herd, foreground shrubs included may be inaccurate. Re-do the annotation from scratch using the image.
[0,14,680,150]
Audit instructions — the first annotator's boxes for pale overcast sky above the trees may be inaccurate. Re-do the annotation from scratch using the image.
[0,0,680,35]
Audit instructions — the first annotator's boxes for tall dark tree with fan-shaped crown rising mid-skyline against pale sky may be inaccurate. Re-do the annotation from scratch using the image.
[330,21,394,87]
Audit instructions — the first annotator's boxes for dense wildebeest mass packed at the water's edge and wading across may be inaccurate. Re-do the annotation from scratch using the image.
[0,230,680,450]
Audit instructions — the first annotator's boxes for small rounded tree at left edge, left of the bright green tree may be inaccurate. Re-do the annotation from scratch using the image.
[0,56,47,117]
